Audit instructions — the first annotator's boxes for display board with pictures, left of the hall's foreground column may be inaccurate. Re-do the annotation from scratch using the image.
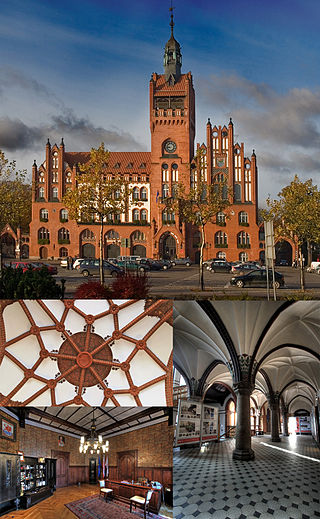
[175,399,219,446]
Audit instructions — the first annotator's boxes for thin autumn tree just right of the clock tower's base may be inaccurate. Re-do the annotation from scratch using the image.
[172,148,230,290]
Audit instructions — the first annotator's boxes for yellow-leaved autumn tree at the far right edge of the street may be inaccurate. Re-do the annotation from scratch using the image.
[265,175,320,290]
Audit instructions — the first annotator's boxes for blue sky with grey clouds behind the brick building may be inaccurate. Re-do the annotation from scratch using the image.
[0,0,320,205]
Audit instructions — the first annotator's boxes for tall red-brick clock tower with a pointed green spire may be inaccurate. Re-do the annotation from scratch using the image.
[149,8,195,259]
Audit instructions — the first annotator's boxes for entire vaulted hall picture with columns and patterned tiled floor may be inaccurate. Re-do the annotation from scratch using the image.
[173,300,320,519]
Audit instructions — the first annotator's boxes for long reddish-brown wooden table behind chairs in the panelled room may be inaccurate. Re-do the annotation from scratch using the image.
[106,479,161,514]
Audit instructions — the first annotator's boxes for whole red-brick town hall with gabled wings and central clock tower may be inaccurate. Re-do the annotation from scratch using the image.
[25,15,291,261]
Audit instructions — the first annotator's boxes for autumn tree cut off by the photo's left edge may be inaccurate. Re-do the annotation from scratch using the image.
[0,150,31,231]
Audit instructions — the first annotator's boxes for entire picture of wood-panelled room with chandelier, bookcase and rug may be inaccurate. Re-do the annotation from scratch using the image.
[0,406,173,519]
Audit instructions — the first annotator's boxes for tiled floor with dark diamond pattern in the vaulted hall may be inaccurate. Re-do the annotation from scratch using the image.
[174,436,320,519]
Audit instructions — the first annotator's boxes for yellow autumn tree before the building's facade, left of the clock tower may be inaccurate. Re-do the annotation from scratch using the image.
[63,143,129,283]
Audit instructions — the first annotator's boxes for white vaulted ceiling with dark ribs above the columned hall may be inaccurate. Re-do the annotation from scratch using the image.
[174,301,320,409]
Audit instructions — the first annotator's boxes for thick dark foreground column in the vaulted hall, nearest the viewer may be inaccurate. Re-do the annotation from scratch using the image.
[233,381,254,460]
